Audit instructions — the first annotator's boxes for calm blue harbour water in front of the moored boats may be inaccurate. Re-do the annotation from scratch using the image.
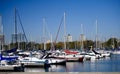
[25,55,120,72]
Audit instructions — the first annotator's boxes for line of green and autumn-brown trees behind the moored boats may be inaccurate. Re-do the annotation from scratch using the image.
[3,38,120,50]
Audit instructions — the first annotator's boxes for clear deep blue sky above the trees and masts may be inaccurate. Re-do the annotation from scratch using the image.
[0,0,120,42]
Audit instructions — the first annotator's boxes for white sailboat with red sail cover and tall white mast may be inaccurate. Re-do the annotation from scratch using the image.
[53,12,84,61]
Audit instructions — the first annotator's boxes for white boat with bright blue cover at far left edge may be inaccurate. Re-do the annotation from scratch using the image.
[0,9,24,72]
